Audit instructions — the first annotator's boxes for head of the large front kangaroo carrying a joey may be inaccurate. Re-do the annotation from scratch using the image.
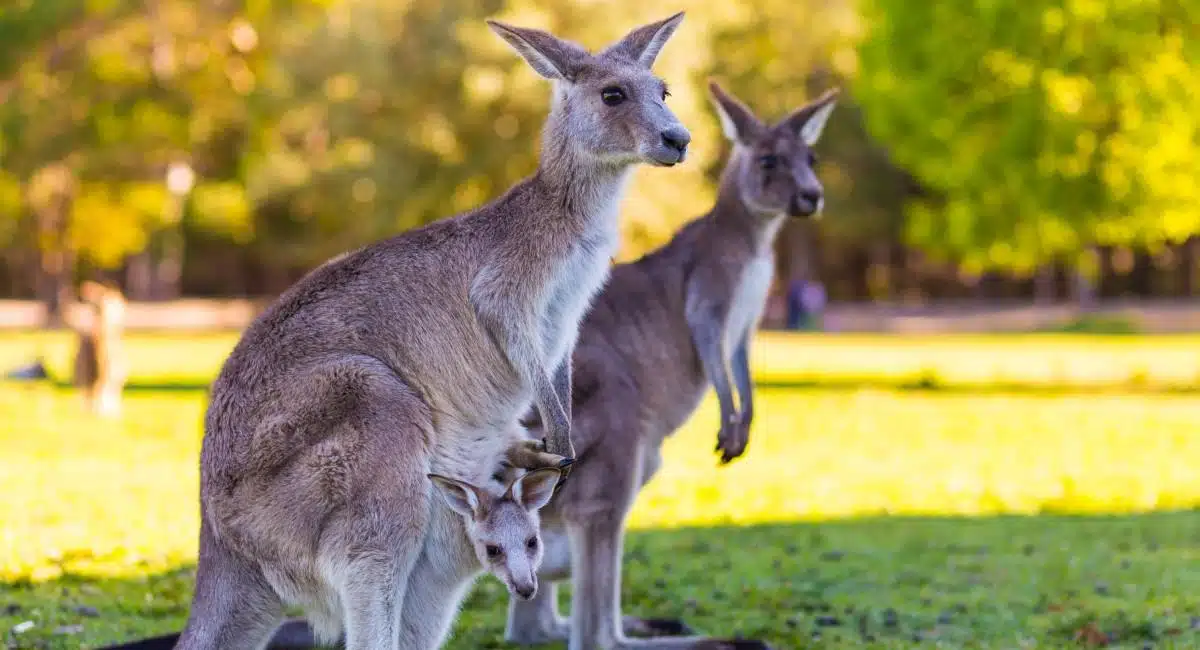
[487,12,691,167]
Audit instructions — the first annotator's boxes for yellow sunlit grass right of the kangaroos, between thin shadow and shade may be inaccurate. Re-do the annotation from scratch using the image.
[632,389,1200,528]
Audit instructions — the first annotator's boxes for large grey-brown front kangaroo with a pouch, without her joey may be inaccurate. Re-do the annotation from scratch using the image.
[178,13,690,650]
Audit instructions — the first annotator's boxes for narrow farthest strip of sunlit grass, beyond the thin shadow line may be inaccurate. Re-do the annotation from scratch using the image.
[0,332,1200,391]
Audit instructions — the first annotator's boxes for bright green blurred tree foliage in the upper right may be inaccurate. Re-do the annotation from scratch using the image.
[856,0,1200,275]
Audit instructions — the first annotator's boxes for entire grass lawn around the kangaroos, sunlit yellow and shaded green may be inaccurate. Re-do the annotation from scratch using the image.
[0,335,1200,650]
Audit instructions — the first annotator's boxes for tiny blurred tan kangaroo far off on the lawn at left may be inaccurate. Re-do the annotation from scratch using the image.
[73,282,127,416]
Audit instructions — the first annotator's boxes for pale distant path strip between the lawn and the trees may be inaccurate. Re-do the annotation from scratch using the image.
[0,299,1200,333]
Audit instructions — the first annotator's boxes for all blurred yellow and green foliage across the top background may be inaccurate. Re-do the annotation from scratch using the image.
[0,0,1200,290]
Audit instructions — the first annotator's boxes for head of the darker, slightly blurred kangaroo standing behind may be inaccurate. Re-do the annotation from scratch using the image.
[708,82,838,217]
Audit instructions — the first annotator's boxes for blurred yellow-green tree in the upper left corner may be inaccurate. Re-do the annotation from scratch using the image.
[0,0,328,321]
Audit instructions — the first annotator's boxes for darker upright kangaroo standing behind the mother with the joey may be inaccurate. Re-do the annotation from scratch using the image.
[505,83,838,650]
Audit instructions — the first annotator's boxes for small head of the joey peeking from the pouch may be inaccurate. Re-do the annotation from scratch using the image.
[430,468,562,600]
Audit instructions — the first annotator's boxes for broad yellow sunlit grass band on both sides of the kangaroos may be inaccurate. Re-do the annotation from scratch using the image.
[0,384,1200,579]
